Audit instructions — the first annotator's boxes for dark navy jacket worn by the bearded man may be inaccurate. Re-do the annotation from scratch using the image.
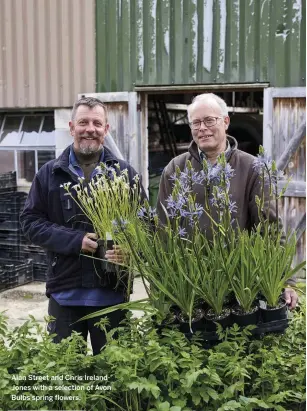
[20,147,146,296]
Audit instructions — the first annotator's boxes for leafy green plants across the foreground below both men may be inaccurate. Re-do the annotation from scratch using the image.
[0,304,306,411]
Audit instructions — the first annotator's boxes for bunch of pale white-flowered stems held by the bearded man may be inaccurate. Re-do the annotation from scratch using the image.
[63,163,144,296]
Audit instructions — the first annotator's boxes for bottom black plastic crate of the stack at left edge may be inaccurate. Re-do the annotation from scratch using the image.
[0,259,33,289]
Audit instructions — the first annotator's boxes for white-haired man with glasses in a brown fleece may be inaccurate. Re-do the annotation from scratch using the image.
[157,93,297,308]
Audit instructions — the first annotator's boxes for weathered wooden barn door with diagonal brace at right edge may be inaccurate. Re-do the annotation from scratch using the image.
[263,87,306,276]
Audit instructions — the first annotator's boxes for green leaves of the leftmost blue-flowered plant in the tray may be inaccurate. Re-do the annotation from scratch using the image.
[118,212,202,332]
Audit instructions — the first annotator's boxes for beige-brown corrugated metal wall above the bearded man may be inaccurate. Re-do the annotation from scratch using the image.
[0,0,96,108]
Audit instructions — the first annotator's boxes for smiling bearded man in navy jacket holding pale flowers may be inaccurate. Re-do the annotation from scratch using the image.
[20,97,144,355]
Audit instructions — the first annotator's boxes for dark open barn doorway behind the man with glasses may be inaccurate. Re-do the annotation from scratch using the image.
[148,89,263,205]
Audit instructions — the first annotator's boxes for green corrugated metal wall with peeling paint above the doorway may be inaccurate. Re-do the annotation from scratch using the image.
[96,0,306,92]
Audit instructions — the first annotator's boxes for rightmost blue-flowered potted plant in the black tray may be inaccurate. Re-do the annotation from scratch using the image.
[254,147,305,322]
